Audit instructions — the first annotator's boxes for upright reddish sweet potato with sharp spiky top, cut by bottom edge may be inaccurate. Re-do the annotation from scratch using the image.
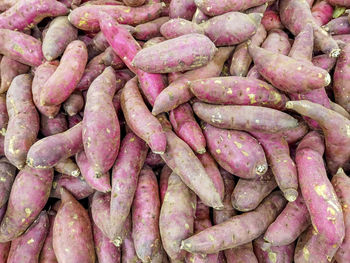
[53,188,95,263]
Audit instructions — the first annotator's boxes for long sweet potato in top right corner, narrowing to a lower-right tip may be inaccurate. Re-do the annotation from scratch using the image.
[279,0,340,57]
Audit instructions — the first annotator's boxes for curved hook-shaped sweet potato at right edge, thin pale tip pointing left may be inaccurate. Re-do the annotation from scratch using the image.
[286,100,350,173]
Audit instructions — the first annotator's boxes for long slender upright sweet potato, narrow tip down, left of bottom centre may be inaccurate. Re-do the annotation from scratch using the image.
[110,133,148,244]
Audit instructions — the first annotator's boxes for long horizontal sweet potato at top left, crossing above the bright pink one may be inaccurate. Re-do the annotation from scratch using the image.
[68,3,163,32]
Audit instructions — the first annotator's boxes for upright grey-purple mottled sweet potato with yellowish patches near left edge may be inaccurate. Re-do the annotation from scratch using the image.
[4,74,39,169]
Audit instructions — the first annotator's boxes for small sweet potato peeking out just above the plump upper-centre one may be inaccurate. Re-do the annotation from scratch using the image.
[160,18,204,39]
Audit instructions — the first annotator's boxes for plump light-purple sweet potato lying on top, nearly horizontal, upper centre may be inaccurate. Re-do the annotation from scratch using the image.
[132,33,217,73]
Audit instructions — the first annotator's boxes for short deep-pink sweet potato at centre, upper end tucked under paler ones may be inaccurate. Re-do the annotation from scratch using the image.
[169,103,206,153]
